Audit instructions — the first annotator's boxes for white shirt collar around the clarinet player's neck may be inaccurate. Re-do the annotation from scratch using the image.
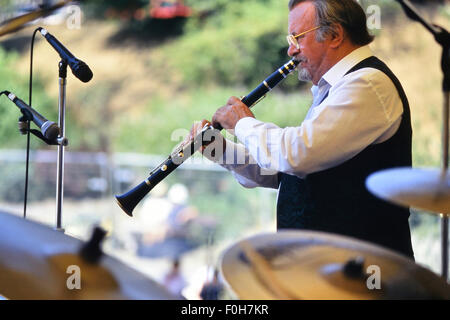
[318,45,373,86]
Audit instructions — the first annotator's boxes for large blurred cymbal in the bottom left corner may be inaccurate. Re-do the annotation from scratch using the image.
[0,212,177,300]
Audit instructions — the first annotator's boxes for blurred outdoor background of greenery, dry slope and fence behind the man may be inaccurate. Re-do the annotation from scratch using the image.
[0,0,450,299]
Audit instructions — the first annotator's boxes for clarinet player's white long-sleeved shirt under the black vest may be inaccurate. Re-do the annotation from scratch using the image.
[216,46,403,188]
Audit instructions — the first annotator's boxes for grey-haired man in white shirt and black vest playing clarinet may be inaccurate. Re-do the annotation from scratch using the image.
[191,0,413,258]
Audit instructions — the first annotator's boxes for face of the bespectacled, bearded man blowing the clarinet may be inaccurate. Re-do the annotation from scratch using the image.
[288,2,328,84]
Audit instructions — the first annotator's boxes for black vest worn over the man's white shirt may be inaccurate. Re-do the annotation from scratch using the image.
[277,57,413,258]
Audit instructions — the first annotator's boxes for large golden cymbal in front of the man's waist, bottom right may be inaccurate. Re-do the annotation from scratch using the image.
[221,230,450,300]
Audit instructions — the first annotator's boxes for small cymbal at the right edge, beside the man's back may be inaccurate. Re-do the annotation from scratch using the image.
[366,168,450,213]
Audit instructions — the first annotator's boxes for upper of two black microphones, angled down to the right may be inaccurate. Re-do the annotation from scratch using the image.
[39,27,93,82]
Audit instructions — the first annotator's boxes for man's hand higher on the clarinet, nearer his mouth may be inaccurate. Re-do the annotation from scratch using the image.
[212,97,255,130]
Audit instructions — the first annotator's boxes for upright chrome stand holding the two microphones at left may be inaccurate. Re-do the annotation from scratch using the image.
[56,60,67,232]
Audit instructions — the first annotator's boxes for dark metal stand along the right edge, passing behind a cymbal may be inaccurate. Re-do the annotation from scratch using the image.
[397,0,450,281]
